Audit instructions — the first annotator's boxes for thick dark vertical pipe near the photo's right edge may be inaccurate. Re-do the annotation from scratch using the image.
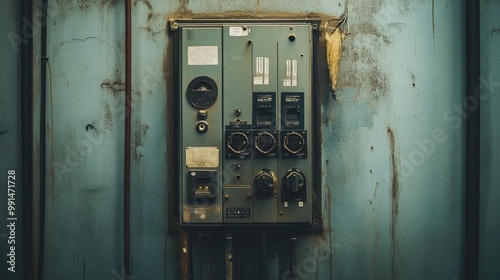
[465,0,481,279]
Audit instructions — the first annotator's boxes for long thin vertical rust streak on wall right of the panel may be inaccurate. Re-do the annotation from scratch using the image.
[387,128,399,279]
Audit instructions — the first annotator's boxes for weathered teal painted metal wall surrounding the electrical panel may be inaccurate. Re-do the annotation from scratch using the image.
[0,0,500,279]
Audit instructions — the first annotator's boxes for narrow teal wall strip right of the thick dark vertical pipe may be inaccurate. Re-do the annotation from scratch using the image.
[479,1,500,279]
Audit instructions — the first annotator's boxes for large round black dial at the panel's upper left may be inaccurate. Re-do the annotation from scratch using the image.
[187,76,217,109]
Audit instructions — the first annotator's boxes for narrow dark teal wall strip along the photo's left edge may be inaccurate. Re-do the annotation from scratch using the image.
[0,0,24,279]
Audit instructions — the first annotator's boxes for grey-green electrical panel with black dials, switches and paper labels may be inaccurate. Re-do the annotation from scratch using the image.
[176,22,318,225]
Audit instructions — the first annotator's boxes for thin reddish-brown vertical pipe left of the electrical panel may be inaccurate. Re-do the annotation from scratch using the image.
[123,0,132,276]
